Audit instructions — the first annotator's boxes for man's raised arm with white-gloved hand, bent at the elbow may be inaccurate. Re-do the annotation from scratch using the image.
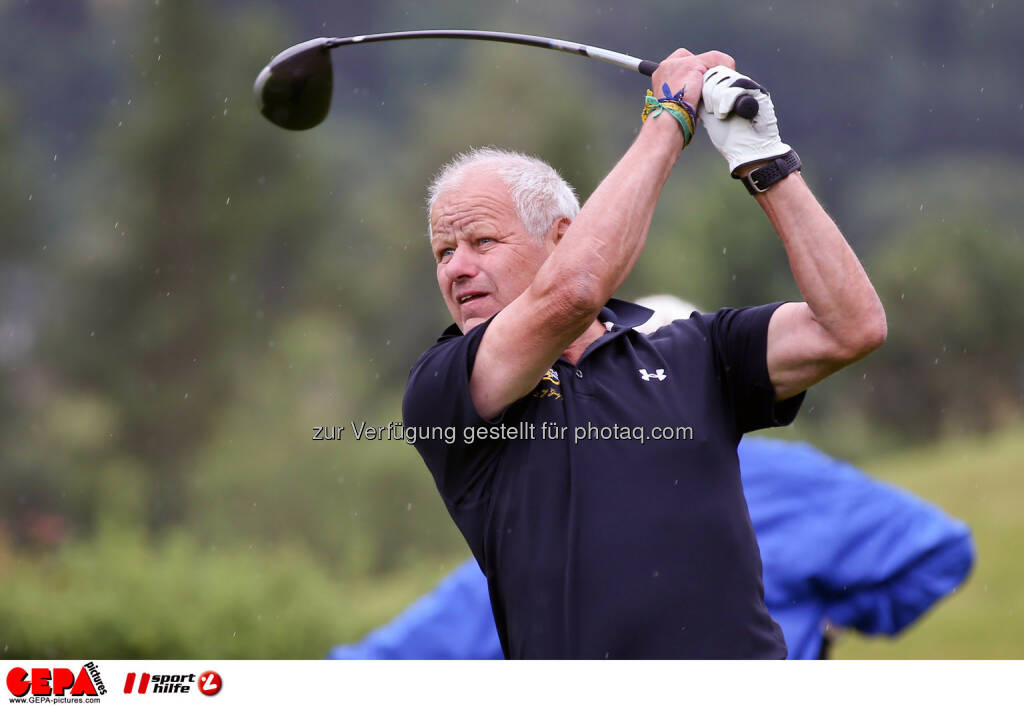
[700,67,887,400]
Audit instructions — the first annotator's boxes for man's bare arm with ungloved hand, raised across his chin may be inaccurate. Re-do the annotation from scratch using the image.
[470,49,732,419]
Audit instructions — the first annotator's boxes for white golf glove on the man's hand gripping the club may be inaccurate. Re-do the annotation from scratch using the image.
[697,67,790,174]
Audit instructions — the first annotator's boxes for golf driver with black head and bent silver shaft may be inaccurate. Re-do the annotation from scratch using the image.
[253,30,758,130]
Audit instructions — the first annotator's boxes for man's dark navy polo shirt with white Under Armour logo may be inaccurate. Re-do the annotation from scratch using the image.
[402,299,803,659]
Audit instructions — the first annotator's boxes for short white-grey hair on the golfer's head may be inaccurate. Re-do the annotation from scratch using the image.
[427,147,580,238]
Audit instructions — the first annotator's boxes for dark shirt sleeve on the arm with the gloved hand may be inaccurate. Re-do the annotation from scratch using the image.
[701,301,805,433]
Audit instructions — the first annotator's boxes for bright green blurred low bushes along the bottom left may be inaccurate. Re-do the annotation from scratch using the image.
[0,532,454,660]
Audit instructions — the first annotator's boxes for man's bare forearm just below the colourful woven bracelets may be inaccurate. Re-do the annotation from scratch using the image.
[535,115,683,314]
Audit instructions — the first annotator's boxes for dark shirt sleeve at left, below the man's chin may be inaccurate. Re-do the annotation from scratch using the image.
[402,321,504,509]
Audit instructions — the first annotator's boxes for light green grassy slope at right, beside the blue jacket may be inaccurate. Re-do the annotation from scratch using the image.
[835,426,1024,659]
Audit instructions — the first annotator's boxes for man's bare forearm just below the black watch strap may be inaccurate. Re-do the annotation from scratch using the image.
[756,172,886,357]
